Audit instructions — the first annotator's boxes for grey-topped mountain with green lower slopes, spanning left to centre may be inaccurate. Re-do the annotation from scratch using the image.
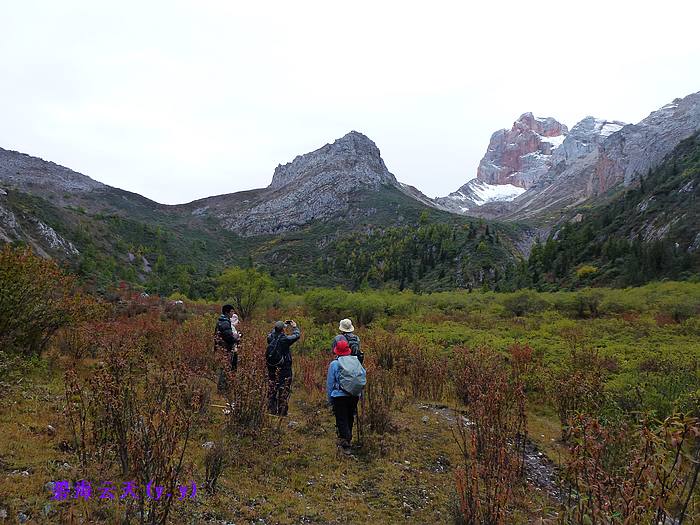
[0,132,520,297]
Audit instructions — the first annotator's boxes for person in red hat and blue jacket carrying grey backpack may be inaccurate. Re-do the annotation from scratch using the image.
[326,339,367,454]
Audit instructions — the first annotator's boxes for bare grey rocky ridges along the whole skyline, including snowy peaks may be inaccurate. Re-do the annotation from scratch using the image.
[0,93,700,268]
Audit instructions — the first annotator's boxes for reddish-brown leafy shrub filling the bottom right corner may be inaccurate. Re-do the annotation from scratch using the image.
[560,416,700,524]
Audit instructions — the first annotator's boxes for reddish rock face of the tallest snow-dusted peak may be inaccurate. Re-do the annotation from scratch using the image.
[477,113,569,189]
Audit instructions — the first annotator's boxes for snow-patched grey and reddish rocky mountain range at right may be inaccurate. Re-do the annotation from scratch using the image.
[436,92,700,222]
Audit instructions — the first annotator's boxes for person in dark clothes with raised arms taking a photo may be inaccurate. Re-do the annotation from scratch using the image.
[265,320,301,416]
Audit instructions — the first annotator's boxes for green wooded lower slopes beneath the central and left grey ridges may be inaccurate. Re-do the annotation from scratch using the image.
[0,180,522,299]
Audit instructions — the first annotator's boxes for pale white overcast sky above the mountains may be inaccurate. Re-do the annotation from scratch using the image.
[0,0,700,204]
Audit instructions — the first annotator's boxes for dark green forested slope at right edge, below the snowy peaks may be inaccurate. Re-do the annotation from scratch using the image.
[529,133,700,285]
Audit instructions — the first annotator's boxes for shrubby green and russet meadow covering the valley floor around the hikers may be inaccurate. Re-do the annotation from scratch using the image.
[0,247,700,524]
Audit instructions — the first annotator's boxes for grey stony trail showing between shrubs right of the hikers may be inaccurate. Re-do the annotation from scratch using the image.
[418,404,564,502]
